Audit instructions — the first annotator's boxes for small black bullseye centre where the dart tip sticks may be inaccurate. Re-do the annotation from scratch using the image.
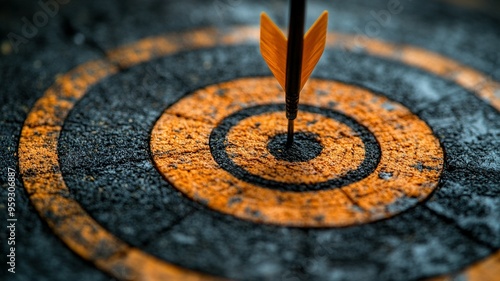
[267,132,323,162]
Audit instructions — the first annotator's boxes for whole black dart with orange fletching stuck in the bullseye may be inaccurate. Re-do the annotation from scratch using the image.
[260,0,328,147]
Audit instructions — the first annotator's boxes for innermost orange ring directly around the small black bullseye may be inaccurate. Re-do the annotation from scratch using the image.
[226,111,365,184]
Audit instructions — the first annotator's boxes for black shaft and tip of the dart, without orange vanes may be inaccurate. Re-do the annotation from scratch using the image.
[285,0,306,144]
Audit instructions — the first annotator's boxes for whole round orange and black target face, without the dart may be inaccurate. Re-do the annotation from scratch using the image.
[3,0,500,280]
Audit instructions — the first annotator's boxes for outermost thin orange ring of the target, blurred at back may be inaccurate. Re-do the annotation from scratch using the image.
[18,27,500,280]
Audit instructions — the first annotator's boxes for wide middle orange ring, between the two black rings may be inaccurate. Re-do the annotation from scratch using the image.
[150,77,444,227]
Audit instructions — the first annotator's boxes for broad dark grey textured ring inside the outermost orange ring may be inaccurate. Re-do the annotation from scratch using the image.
[52,46,500,280]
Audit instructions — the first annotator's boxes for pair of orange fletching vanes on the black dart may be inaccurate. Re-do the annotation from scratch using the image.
[260,11,328,89]
